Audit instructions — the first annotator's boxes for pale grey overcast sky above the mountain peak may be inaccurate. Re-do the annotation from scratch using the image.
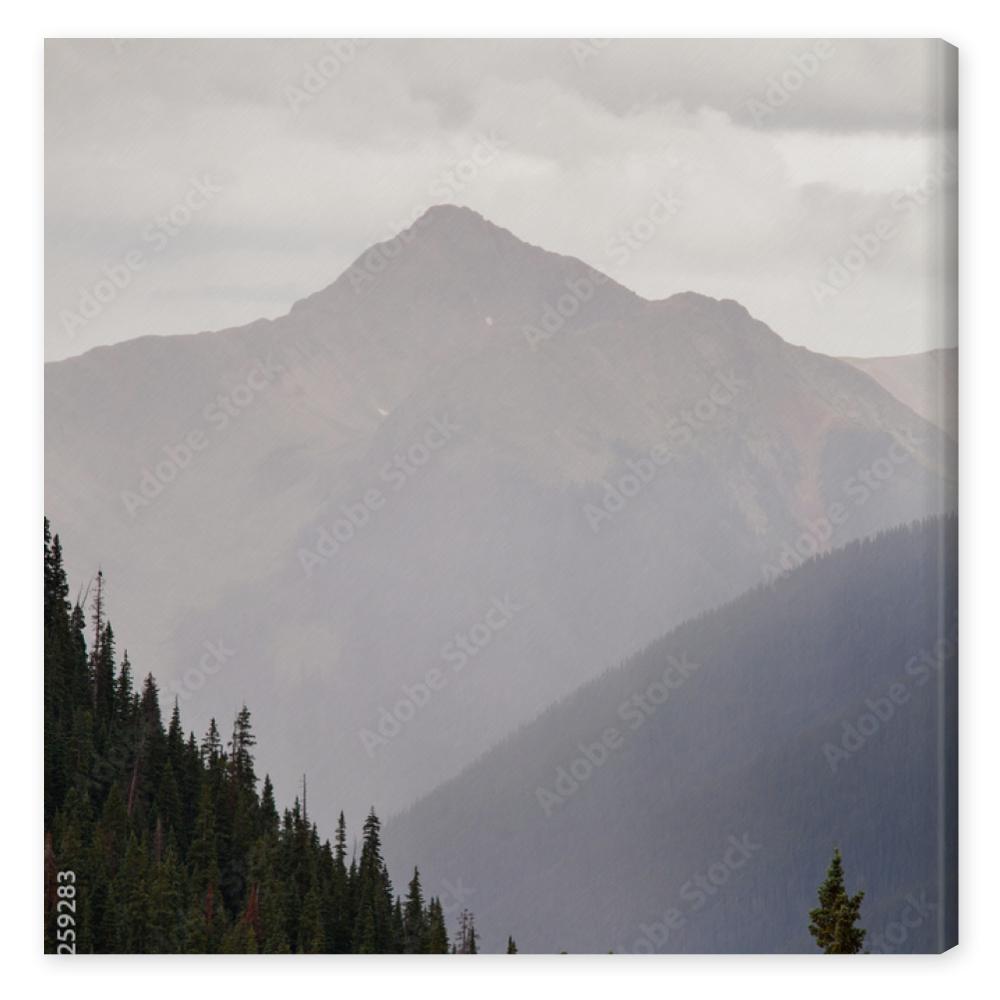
[45,40,955,368]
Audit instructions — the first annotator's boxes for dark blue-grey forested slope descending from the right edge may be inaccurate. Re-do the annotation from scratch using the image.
[388,519,957,952]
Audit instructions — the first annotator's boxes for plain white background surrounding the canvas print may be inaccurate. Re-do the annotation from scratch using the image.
[0,0,1000,1000]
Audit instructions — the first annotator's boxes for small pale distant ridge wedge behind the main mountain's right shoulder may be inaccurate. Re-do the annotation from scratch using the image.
[842,347,958,441]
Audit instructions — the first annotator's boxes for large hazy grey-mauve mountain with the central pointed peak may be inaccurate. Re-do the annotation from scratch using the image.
[46,201,954,825]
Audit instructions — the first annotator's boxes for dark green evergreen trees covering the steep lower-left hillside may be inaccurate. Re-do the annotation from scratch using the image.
[44,520,488,954]
